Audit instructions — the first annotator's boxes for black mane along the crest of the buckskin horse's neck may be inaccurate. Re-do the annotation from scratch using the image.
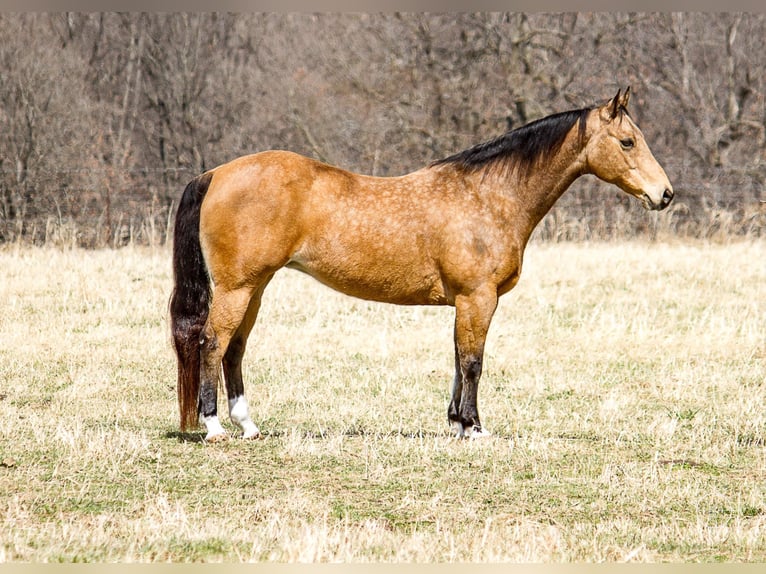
[431,108,592,179]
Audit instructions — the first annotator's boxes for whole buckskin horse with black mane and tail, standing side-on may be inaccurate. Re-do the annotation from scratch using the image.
[169,87,673,442]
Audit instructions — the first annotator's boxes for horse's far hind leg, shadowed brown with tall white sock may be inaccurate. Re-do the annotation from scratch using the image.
[223,277,271,439]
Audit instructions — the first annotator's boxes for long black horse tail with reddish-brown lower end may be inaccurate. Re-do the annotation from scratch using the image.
[170,172,212,431]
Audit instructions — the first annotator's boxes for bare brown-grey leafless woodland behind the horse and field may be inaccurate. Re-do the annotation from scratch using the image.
[0,12,766,247]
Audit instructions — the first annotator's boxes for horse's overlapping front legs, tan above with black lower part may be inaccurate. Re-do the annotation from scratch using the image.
[448,286,497,438]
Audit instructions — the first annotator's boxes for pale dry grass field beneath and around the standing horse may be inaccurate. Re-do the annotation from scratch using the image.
[0,240,766,562]
